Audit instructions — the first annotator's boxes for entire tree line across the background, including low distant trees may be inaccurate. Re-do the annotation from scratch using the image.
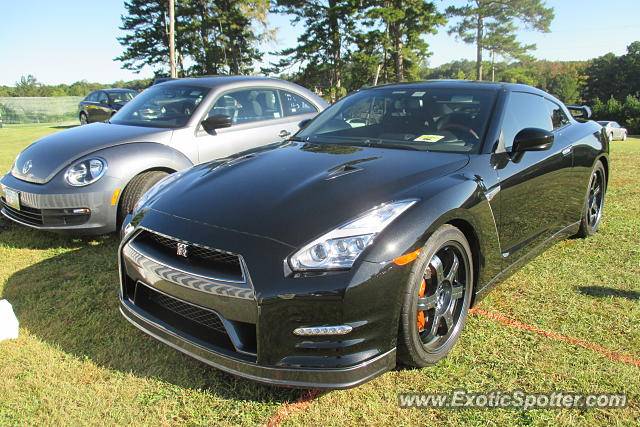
[0,0,640,130]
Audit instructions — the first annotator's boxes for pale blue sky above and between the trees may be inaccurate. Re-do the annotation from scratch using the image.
[0,0,640,86]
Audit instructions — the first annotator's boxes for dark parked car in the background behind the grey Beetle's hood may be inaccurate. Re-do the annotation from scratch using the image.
[78,89,138,125]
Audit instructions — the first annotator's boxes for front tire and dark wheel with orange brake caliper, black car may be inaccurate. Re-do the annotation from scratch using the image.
[397,224,473,367]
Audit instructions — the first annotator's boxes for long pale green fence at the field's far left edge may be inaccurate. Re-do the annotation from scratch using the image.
[0,96,82,124]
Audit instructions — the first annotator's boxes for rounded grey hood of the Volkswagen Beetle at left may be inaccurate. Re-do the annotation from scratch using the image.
[11,123,173,184]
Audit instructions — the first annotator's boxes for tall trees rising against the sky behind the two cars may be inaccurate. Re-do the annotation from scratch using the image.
[116,0,554,101]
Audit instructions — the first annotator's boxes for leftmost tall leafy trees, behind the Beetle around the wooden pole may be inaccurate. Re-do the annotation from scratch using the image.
[116,0,272,75]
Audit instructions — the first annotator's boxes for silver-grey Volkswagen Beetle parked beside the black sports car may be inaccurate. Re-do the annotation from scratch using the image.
[0,76,327,234]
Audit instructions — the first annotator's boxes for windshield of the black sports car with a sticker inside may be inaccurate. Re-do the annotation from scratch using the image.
[296,85,495,153]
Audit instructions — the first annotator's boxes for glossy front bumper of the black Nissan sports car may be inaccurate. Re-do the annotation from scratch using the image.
[119,212,409,388]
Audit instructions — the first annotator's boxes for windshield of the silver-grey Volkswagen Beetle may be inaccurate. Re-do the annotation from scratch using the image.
[109,85,209,128]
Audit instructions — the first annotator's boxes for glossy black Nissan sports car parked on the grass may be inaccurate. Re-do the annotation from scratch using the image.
[120,81,609,388]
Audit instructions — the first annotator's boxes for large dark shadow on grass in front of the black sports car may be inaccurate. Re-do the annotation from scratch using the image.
[3,238,303,402]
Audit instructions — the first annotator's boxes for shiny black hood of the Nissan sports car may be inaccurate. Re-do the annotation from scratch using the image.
[147,143,469,247]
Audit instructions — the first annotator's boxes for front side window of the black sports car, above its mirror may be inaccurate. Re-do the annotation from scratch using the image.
[502,92,553,150]
